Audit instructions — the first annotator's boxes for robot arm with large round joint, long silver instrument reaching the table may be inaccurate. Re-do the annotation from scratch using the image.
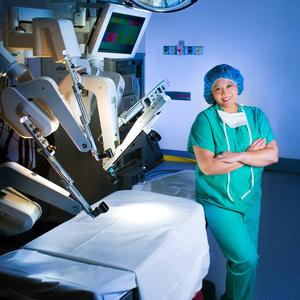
[0,42,108,221]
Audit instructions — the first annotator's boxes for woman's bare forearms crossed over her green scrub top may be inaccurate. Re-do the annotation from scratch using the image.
[193,139,278,175]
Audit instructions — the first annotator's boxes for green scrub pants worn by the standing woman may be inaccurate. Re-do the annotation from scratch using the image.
[203,201,260,300]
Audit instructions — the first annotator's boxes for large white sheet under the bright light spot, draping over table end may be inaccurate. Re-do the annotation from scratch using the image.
[0,190,209,300]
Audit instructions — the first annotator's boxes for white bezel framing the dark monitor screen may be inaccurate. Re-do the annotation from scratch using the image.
[87,3,151,58]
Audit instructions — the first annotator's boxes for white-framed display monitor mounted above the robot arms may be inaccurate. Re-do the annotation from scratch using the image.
[87,3,151,58]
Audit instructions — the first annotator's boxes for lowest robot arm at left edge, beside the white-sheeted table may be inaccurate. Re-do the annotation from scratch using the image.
[0,162,82,236]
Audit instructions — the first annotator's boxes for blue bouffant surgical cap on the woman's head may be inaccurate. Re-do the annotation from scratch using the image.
[204,64,244,104]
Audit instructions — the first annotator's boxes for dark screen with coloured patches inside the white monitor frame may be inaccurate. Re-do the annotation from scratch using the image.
[98,13,145,54]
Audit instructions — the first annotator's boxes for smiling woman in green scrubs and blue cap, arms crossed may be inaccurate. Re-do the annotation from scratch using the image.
[188,64,278,300]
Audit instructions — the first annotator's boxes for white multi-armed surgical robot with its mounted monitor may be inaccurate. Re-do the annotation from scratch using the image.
[0,4,169,235]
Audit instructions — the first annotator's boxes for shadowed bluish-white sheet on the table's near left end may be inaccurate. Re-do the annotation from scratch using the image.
[0,249,136,300]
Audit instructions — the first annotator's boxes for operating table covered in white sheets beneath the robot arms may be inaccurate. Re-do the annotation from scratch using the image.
[0,190,209,300]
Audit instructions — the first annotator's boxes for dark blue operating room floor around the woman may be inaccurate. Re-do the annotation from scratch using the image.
[148,163,300,300]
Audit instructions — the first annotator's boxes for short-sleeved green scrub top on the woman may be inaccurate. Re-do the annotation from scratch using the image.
[187,104,275,212]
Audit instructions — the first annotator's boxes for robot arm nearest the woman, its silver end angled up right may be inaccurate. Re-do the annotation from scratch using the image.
[59,68,170,180]
